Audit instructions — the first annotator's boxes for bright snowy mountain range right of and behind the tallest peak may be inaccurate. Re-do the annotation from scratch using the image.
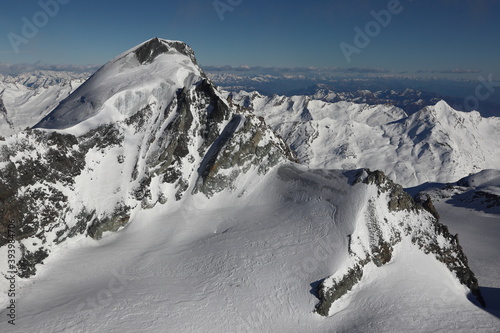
[226,92,500,186]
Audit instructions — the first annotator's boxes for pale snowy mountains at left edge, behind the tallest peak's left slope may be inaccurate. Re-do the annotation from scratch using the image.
[0,71,89,137]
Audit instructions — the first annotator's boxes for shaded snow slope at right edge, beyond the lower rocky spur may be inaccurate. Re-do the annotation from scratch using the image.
[410,170,500,322]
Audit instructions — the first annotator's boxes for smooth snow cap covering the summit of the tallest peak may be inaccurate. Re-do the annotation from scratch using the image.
[35,38,205,130]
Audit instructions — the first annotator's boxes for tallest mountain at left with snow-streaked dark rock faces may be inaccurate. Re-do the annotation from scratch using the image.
[0,39,293,277]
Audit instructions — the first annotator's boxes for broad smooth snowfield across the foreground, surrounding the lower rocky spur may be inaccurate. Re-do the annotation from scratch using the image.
[1,169,500,333]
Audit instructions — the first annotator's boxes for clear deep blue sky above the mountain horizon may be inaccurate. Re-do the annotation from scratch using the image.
[0,0,500,80]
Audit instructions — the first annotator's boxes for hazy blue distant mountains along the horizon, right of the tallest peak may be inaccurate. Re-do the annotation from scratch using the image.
[208,71,500,117]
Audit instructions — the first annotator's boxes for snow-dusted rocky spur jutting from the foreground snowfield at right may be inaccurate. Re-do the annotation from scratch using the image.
[316,169,485,316]
